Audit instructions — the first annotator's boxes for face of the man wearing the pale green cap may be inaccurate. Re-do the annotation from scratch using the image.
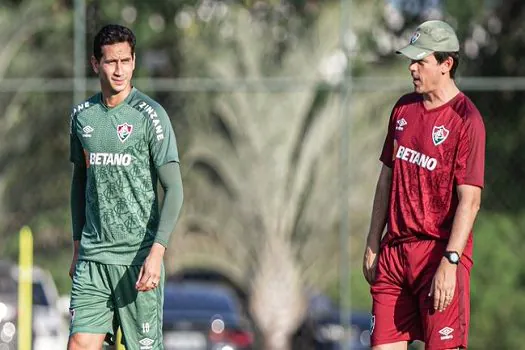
[408,54,449,94]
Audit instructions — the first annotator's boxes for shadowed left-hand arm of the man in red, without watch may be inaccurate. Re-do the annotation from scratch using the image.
[363,165,392,284]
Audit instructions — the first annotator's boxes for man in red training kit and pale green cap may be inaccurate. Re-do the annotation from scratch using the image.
[363,21,485,350]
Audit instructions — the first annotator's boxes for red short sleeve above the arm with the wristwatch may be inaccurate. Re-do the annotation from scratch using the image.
[454,113,485,188]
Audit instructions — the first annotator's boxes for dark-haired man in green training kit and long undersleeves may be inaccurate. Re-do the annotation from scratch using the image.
[68,25,183,350]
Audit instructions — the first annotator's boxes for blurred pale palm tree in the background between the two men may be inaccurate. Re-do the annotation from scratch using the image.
[166,2,400,350]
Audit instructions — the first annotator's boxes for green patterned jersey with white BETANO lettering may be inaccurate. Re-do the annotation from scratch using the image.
[70,88,179,265]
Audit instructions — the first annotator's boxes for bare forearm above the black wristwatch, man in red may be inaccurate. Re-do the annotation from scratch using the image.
[447,185,481,256]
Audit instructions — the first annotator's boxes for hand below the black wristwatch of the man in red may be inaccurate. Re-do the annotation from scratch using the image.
[428,258,458,312]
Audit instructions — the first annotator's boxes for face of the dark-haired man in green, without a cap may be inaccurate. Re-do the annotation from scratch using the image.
[91,42,135,95]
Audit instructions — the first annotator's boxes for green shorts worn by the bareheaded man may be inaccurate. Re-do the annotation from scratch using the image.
[69,261,165,350]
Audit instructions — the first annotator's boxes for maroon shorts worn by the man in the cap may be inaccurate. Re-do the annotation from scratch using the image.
[371,240,470,350]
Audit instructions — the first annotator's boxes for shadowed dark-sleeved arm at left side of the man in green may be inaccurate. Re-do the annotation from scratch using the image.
[69,164,86,277]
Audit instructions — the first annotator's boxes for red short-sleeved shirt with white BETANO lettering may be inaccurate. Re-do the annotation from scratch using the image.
[380,92,485,261]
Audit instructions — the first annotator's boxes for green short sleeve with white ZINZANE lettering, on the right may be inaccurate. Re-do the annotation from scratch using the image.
[148,107,179,168]
